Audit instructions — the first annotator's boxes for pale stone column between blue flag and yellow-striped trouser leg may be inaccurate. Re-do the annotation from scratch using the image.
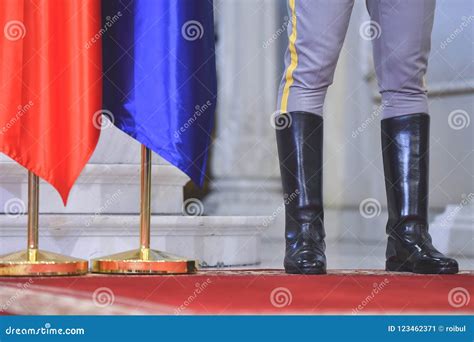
[204,0,288,230]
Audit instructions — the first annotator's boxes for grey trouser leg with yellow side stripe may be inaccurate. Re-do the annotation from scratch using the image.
[277,0,354,115]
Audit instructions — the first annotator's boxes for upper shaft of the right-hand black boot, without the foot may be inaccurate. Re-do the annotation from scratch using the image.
[381,113,430,234]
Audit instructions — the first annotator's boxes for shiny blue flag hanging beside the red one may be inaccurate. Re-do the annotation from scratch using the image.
[100,0,217,185]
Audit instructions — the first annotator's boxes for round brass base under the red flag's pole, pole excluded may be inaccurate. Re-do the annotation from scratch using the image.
[0,249,88,277]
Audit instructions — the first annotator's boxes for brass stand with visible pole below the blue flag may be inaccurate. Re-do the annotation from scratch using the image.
[92,145,197,274]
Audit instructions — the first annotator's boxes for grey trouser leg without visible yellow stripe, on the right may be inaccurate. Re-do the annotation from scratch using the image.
[367,0,436,118]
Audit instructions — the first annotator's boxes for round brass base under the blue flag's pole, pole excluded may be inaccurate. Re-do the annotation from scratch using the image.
[92,248,197,274]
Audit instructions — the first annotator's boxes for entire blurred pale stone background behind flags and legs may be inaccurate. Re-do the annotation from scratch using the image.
[0,0,474,270]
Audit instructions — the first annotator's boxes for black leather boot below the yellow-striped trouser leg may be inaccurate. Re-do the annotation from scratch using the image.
[276,112,326,274]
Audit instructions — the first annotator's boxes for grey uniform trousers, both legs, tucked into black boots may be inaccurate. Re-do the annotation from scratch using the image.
[278,0,436,118]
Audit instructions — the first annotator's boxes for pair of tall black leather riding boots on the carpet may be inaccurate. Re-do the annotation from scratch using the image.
[276,112,458,274]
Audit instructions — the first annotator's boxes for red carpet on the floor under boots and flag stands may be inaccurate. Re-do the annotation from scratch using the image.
[0,270,474,314]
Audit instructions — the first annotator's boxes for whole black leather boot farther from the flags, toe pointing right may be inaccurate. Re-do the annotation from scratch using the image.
[382,113,458,274]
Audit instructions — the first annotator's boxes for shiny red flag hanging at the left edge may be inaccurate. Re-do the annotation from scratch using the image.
[0,0,102,204]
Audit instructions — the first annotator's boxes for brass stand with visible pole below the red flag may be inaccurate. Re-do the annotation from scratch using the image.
[0,172,88,277]
